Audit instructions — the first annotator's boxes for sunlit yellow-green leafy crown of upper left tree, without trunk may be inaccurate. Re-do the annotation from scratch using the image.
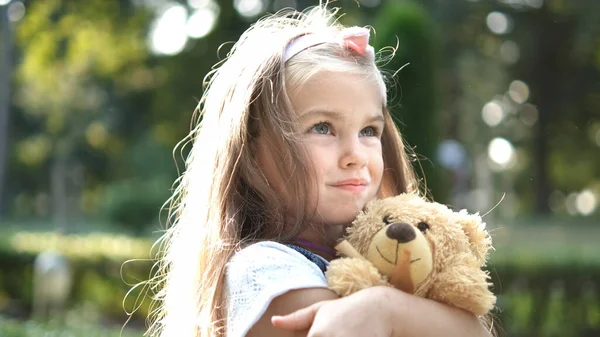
[17,0,148,124]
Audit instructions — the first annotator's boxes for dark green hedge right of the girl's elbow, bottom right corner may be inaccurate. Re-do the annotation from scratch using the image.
[491,264,600,337]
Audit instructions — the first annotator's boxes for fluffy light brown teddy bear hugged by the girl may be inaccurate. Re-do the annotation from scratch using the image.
[326,193,496,316]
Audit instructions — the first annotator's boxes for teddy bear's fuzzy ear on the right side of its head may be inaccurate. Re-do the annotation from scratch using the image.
[457,210,493,266]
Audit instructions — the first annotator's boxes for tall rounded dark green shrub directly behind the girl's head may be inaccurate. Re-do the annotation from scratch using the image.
[374,1,446,201]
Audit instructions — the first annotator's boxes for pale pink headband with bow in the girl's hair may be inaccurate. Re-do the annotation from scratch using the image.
[283,27,375,62]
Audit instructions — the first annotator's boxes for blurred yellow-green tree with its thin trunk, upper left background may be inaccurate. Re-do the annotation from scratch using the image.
[16,0,152,226]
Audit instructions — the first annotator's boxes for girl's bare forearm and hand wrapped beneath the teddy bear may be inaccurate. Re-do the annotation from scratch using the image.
[270,287,491,337]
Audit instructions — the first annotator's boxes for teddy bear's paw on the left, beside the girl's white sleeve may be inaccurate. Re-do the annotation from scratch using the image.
[325,257,389,296]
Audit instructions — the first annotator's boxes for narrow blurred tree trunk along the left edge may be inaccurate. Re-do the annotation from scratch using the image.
[0,6,13,217]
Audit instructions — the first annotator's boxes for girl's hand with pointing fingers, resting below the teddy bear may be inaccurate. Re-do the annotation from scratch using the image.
[271,287,402,337]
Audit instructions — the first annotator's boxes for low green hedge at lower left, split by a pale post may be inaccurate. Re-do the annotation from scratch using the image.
[0,245,152,323]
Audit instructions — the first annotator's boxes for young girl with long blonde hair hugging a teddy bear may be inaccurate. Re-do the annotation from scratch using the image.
[150,6,487,337]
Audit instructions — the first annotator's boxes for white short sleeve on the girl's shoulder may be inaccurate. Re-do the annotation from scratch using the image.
[225,241,327,337]
